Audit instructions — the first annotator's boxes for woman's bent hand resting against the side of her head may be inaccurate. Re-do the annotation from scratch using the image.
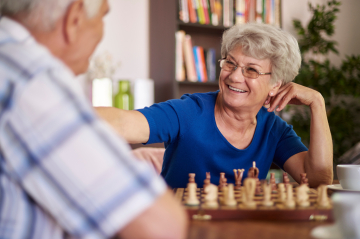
[265,82,323,112]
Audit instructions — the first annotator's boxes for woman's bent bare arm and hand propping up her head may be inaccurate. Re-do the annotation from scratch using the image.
[265,83,333,187]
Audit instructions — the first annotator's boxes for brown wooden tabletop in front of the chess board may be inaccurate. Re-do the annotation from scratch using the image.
[188,181,338,239]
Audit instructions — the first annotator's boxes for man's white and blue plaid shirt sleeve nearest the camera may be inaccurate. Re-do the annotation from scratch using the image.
[1,67,166,238]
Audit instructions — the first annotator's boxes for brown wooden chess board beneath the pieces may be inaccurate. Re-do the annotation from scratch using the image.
[173,186,333,221]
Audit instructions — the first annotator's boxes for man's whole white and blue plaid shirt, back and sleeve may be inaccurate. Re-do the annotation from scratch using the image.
[0,17,166,239]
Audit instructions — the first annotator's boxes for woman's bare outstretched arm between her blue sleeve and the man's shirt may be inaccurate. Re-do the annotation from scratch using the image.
[95,107,150,144]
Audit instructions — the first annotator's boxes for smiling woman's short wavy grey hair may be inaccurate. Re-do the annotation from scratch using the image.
[221,23,301,85]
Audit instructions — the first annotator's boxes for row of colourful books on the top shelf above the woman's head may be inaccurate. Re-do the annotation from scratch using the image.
[179,0,281,27]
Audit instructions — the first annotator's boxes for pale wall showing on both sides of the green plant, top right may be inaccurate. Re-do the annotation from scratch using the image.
[282,0,360,65]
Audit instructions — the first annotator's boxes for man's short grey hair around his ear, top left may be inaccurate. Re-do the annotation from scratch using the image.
[0,0,104,30]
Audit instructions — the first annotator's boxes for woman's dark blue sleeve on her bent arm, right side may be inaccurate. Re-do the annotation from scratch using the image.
[274,120,308,169]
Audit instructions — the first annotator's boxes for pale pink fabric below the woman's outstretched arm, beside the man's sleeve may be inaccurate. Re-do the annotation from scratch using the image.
[132,147,165,174]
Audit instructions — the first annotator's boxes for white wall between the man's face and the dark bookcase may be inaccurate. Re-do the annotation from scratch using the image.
[94,0,149,80]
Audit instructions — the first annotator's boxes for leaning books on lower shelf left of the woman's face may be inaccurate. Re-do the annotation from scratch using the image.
[175,30,216,82]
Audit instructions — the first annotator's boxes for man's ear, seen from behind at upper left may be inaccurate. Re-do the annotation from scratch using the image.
[64,0,87,44]
